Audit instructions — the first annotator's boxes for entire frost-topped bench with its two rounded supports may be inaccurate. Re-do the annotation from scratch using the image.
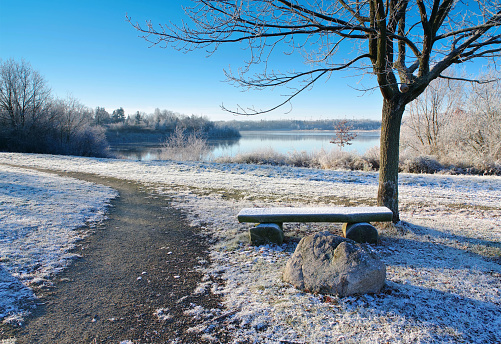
[237,207,393,245]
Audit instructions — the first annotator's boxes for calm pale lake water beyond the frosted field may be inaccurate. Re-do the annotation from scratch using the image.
[112,130,380,161]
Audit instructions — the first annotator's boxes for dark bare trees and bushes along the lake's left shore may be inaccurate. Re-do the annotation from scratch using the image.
[0,60,240,157]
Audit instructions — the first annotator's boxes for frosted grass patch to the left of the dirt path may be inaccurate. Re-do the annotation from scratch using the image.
[0,165,116,324]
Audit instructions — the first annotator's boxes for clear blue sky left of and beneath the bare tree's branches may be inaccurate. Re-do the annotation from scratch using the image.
[0,0,382,120]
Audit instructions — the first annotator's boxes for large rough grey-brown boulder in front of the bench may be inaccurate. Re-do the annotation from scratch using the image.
[283,232,386,297]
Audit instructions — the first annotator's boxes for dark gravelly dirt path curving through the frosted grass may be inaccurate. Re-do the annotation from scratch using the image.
[3,174,225,344]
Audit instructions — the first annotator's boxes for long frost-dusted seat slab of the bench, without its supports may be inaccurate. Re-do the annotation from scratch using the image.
[237,207,393,223]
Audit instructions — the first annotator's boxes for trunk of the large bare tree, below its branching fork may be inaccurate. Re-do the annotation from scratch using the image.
[377,99,405,223]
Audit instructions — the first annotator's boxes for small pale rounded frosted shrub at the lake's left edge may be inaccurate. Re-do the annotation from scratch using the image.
[161,127,210,161]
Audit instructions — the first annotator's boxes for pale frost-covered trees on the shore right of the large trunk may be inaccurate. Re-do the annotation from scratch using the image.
[402,72,501,166]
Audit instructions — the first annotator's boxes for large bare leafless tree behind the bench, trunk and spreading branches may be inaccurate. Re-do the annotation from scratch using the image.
[129,0,501,222]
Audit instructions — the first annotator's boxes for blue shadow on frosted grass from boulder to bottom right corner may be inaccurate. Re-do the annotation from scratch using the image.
[367,282,501,343]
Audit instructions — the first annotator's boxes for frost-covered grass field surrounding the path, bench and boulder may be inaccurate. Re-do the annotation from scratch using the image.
[0,153,501,343]
